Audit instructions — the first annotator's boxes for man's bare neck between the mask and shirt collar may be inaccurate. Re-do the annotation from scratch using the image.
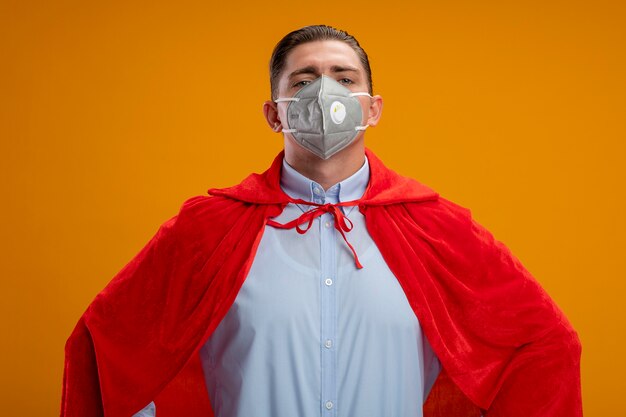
[285,140,365,190]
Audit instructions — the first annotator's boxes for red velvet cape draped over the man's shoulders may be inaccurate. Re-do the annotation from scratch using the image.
[61,150,582,417]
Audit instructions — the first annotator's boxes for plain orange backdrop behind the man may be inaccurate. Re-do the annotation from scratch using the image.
[0,0,626,416]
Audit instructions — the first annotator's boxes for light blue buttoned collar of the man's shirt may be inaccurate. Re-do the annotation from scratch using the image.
[280,156,370,204]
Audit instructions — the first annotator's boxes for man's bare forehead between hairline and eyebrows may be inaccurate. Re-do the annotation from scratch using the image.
[282,40,365,77]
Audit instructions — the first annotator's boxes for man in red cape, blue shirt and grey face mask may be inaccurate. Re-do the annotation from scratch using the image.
[62,26,582,417]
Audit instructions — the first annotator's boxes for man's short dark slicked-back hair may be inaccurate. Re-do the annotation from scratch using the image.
[270,25,373,99]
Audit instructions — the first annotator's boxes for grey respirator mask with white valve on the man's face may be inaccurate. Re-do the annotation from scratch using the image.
[275,75,371,159]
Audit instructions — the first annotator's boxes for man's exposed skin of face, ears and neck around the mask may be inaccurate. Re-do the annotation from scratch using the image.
[263,40,383,190]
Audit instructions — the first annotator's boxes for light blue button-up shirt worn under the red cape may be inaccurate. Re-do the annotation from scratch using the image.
[137,160,440,417]
